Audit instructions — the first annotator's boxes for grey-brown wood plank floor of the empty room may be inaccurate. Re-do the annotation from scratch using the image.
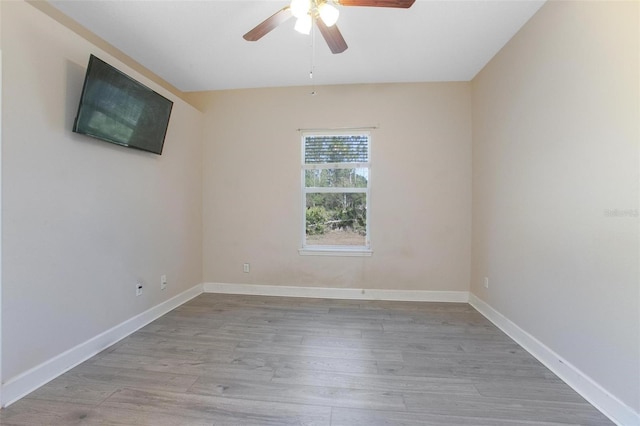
[0,294,612,426]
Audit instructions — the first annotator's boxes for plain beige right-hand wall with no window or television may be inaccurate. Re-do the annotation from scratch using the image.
[471,1,640,412]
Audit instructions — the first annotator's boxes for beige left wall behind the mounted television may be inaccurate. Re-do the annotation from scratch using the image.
[2,2,202,380]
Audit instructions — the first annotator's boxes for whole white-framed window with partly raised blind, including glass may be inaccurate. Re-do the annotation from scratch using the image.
[300,131,371,256]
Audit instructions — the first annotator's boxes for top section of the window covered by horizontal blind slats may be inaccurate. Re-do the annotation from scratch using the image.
[304,135,369,164]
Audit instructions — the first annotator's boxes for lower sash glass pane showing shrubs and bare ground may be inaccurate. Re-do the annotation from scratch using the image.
[305,193,367,246]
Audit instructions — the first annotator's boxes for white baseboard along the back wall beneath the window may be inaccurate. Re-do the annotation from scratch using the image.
[204,283,469,303]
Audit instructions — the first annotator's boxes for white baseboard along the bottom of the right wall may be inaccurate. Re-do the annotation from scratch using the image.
[469,293,640,426]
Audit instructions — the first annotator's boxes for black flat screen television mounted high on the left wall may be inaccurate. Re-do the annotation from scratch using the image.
[73,55,173,155]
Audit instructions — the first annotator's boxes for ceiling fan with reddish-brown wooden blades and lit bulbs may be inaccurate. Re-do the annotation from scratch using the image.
[243,0,415,53]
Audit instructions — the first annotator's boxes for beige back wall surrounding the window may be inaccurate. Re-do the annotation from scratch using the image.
[198,83,471,291]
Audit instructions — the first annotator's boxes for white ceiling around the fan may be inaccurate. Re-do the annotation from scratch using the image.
[50,0,544,91]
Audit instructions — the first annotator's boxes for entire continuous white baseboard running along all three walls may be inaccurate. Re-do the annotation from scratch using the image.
[8,283,640,426]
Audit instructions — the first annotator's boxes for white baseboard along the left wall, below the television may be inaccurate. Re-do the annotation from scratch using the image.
[2,284,202,407]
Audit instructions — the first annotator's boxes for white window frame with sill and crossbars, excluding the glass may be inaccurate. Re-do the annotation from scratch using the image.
[298,129,373,257]
